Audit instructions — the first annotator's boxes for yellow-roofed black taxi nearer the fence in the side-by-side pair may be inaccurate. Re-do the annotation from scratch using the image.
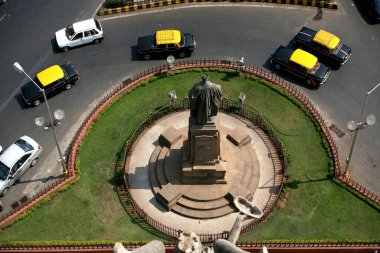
[271,46,330,88]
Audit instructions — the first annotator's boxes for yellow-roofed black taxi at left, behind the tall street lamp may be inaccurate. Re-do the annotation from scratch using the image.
[21,62,79,106]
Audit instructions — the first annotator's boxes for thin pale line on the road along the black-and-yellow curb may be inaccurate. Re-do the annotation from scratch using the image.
[98,3,302,21]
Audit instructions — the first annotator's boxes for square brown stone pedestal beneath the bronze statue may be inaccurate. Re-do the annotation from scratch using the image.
[182,117,227,184]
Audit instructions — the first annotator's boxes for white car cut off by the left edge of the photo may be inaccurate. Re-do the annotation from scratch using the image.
[0,135,42,196]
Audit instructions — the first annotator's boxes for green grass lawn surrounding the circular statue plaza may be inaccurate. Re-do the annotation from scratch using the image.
[0,71,380,243]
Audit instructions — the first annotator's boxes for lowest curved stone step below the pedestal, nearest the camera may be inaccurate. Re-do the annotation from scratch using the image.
[171,205,236,219]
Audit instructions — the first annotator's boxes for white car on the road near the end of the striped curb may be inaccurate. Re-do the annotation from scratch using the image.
[55,18,104,52]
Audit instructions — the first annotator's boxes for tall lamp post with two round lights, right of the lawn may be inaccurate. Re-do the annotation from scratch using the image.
[343,83,380,179]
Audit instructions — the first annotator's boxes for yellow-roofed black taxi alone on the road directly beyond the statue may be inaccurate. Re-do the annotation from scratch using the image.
[137,30,196,60]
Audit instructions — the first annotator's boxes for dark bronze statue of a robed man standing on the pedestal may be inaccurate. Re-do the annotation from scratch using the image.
[189,74,222,125]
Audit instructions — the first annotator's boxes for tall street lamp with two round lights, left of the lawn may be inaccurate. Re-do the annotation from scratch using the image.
[13,62,68,176]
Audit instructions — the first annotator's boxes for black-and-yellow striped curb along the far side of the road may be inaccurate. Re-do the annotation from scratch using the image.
[97,0,338,16]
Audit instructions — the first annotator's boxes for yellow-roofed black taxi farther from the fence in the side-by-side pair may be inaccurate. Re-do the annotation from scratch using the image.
[295,27,351,67]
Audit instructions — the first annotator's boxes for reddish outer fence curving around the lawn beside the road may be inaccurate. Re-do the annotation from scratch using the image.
[0,58,380,235]
